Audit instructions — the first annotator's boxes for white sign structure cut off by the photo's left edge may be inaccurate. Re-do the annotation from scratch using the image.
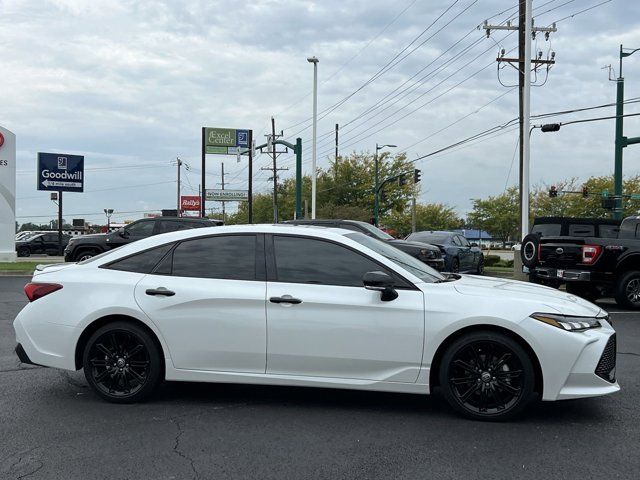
[0,127,16,262]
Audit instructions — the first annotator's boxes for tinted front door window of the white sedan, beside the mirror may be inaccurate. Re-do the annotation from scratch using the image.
[273,234,384,287]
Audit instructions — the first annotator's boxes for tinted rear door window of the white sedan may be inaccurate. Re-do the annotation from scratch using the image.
[171,235,256,280]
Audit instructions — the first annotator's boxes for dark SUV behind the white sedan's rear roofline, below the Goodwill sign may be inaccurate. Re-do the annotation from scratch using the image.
[64,217,222,262]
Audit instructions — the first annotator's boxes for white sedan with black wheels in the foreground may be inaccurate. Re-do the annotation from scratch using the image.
[14,225,620,419]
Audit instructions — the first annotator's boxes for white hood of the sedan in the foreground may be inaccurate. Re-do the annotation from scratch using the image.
[454,275,605,317]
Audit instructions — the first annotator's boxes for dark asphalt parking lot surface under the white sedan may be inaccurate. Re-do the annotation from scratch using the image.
[0,277,640,480]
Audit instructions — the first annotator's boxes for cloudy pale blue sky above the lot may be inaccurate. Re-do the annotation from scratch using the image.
[0,0,640,223]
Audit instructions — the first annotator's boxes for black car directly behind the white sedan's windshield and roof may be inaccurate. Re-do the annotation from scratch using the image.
[284,219,444,271]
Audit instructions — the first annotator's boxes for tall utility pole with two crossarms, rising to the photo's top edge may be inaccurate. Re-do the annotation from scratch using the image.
[483,0,557,238]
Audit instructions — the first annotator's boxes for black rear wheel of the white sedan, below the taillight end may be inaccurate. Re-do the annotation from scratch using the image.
[82,321,164,403]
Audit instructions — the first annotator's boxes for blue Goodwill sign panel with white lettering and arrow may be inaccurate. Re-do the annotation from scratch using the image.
[38,153,84,192]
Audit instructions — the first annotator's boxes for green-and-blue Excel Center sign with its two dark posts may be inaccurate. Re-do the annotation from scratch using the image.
[201,127,253,223]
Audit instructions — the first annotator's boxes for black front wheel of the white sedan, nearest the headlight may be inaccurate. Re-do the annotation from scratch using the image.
[439,331,535,421]
